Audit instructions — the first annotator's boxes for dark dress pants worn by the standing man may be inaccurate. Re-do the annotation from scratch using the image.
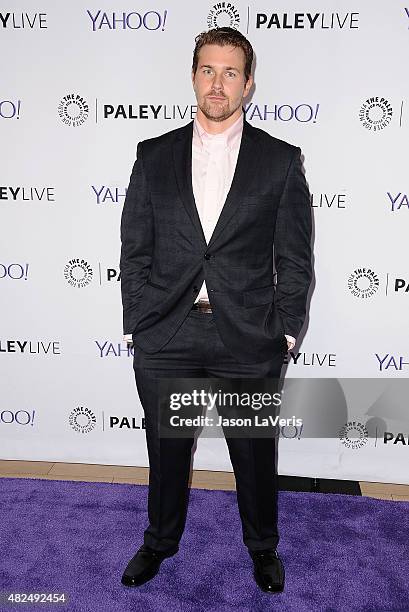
[133,310,287,552]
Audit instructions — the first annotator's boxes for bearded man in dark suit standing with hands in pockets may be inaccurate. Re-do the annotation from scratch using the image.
[120,28,312,592]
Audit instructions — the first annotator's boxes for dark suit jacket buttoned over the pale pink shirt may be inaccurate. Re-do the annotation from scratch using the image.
[120,115,312,363]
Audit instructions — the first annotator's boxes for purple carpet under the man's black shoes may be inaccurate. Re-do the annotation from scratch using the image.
[0,478,409,612]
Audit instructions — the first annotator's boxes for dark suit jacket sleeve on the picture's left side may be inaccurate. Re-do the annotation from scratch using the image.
[119,142,154,334]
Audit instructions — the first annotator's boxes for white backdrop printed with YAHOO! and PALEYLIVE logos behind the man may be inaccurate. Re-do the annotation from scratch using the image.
[0,0,409,483]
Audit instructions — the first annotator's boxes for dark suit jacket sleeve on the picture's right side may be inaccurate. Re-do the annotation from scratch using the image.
[274,147,312,338]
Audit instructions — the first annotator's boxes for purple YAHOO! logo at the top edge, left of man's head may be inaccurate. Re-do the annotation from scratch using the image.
[87,9,168,32]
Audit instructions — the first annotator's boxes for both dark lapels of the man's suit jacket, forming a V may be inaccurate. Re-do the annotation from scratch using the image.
[173,117,257,247]
